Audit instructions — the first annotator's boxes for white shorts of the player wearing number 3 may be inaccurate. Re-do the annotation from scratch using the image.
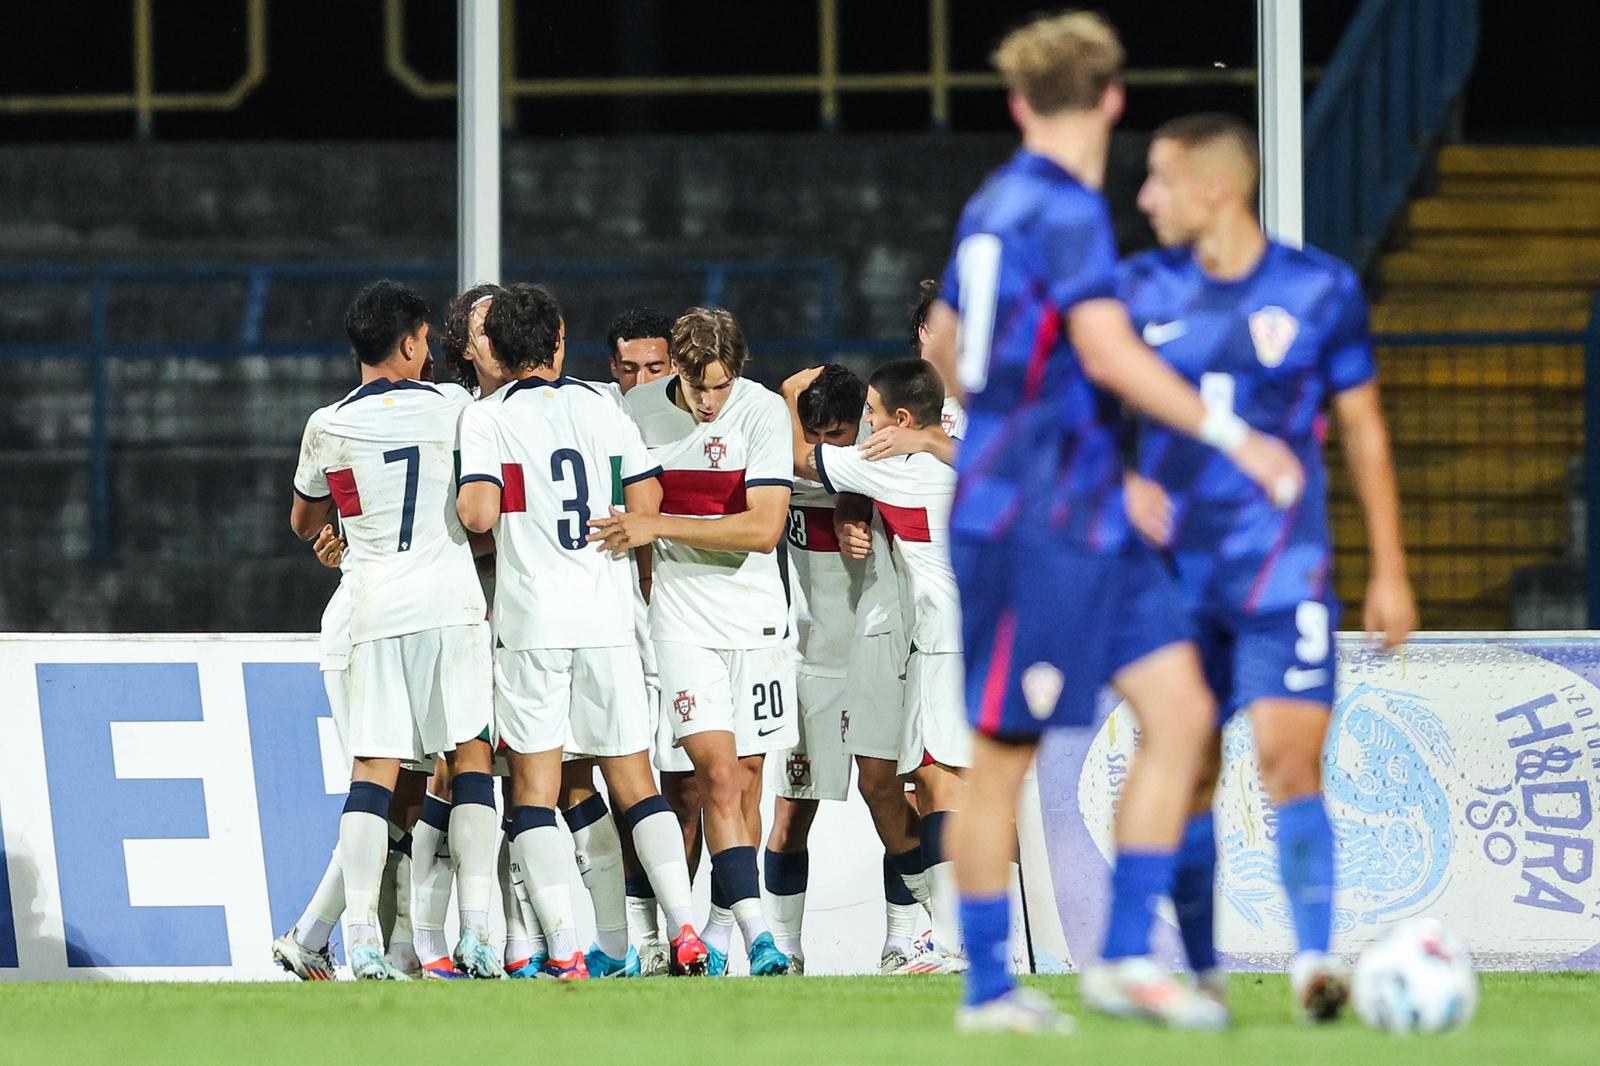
[494,645,650,757]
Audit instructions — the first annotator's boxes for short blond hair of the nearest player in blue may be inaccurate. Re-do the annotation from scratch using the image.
[989,11,1123,115]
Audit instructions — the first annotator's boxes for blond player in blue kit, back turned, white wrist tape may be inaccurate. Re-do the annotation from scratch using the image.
[926,13,1301,1032]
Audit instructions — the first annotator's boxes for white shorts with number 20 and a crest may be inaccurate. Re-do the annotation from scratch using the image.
[656,640,800,759]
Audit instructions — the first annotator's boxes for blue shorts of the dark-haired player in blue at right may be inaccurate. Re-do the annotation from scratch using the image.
[1194,597,1339,723]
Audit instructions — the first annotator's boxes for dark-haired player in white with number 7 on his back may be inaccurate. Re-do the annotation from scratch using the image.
[290,282,504,980]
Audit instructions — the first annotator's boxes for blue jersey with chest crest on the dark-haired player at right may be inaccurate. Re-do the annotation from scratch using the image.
[1117,236,1376,615]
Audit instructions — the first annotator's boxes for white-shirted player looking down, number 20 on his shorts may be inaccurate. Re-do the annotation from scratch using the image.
[594,307,797,975]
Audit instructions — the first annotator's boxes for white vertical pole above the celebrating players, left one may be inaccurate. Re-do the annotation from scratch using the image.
[456,0,501,291]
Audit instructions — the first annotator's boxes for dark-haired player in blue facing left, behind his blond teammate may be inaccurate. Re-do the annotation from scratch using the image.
[1117,115,1416,1020]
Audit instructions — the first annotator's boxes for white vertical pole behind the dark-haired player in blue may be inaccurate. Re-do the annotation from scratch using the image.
[1256,0,1306,248]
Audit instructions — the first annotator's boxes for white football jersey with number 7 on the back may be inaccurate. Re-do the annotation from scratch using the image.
[294,379,485,643]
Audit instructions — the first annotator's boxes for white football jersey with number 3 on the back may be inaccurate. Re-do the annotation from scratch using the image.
[461,378,661,651]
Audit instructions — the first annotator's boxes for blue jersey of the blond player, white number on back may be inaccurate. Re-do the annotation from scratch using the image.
[941,149,1128,552]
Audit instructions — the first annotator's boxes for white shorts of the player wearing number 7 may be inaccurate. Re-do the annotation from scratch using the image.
[349,623,494,760]
